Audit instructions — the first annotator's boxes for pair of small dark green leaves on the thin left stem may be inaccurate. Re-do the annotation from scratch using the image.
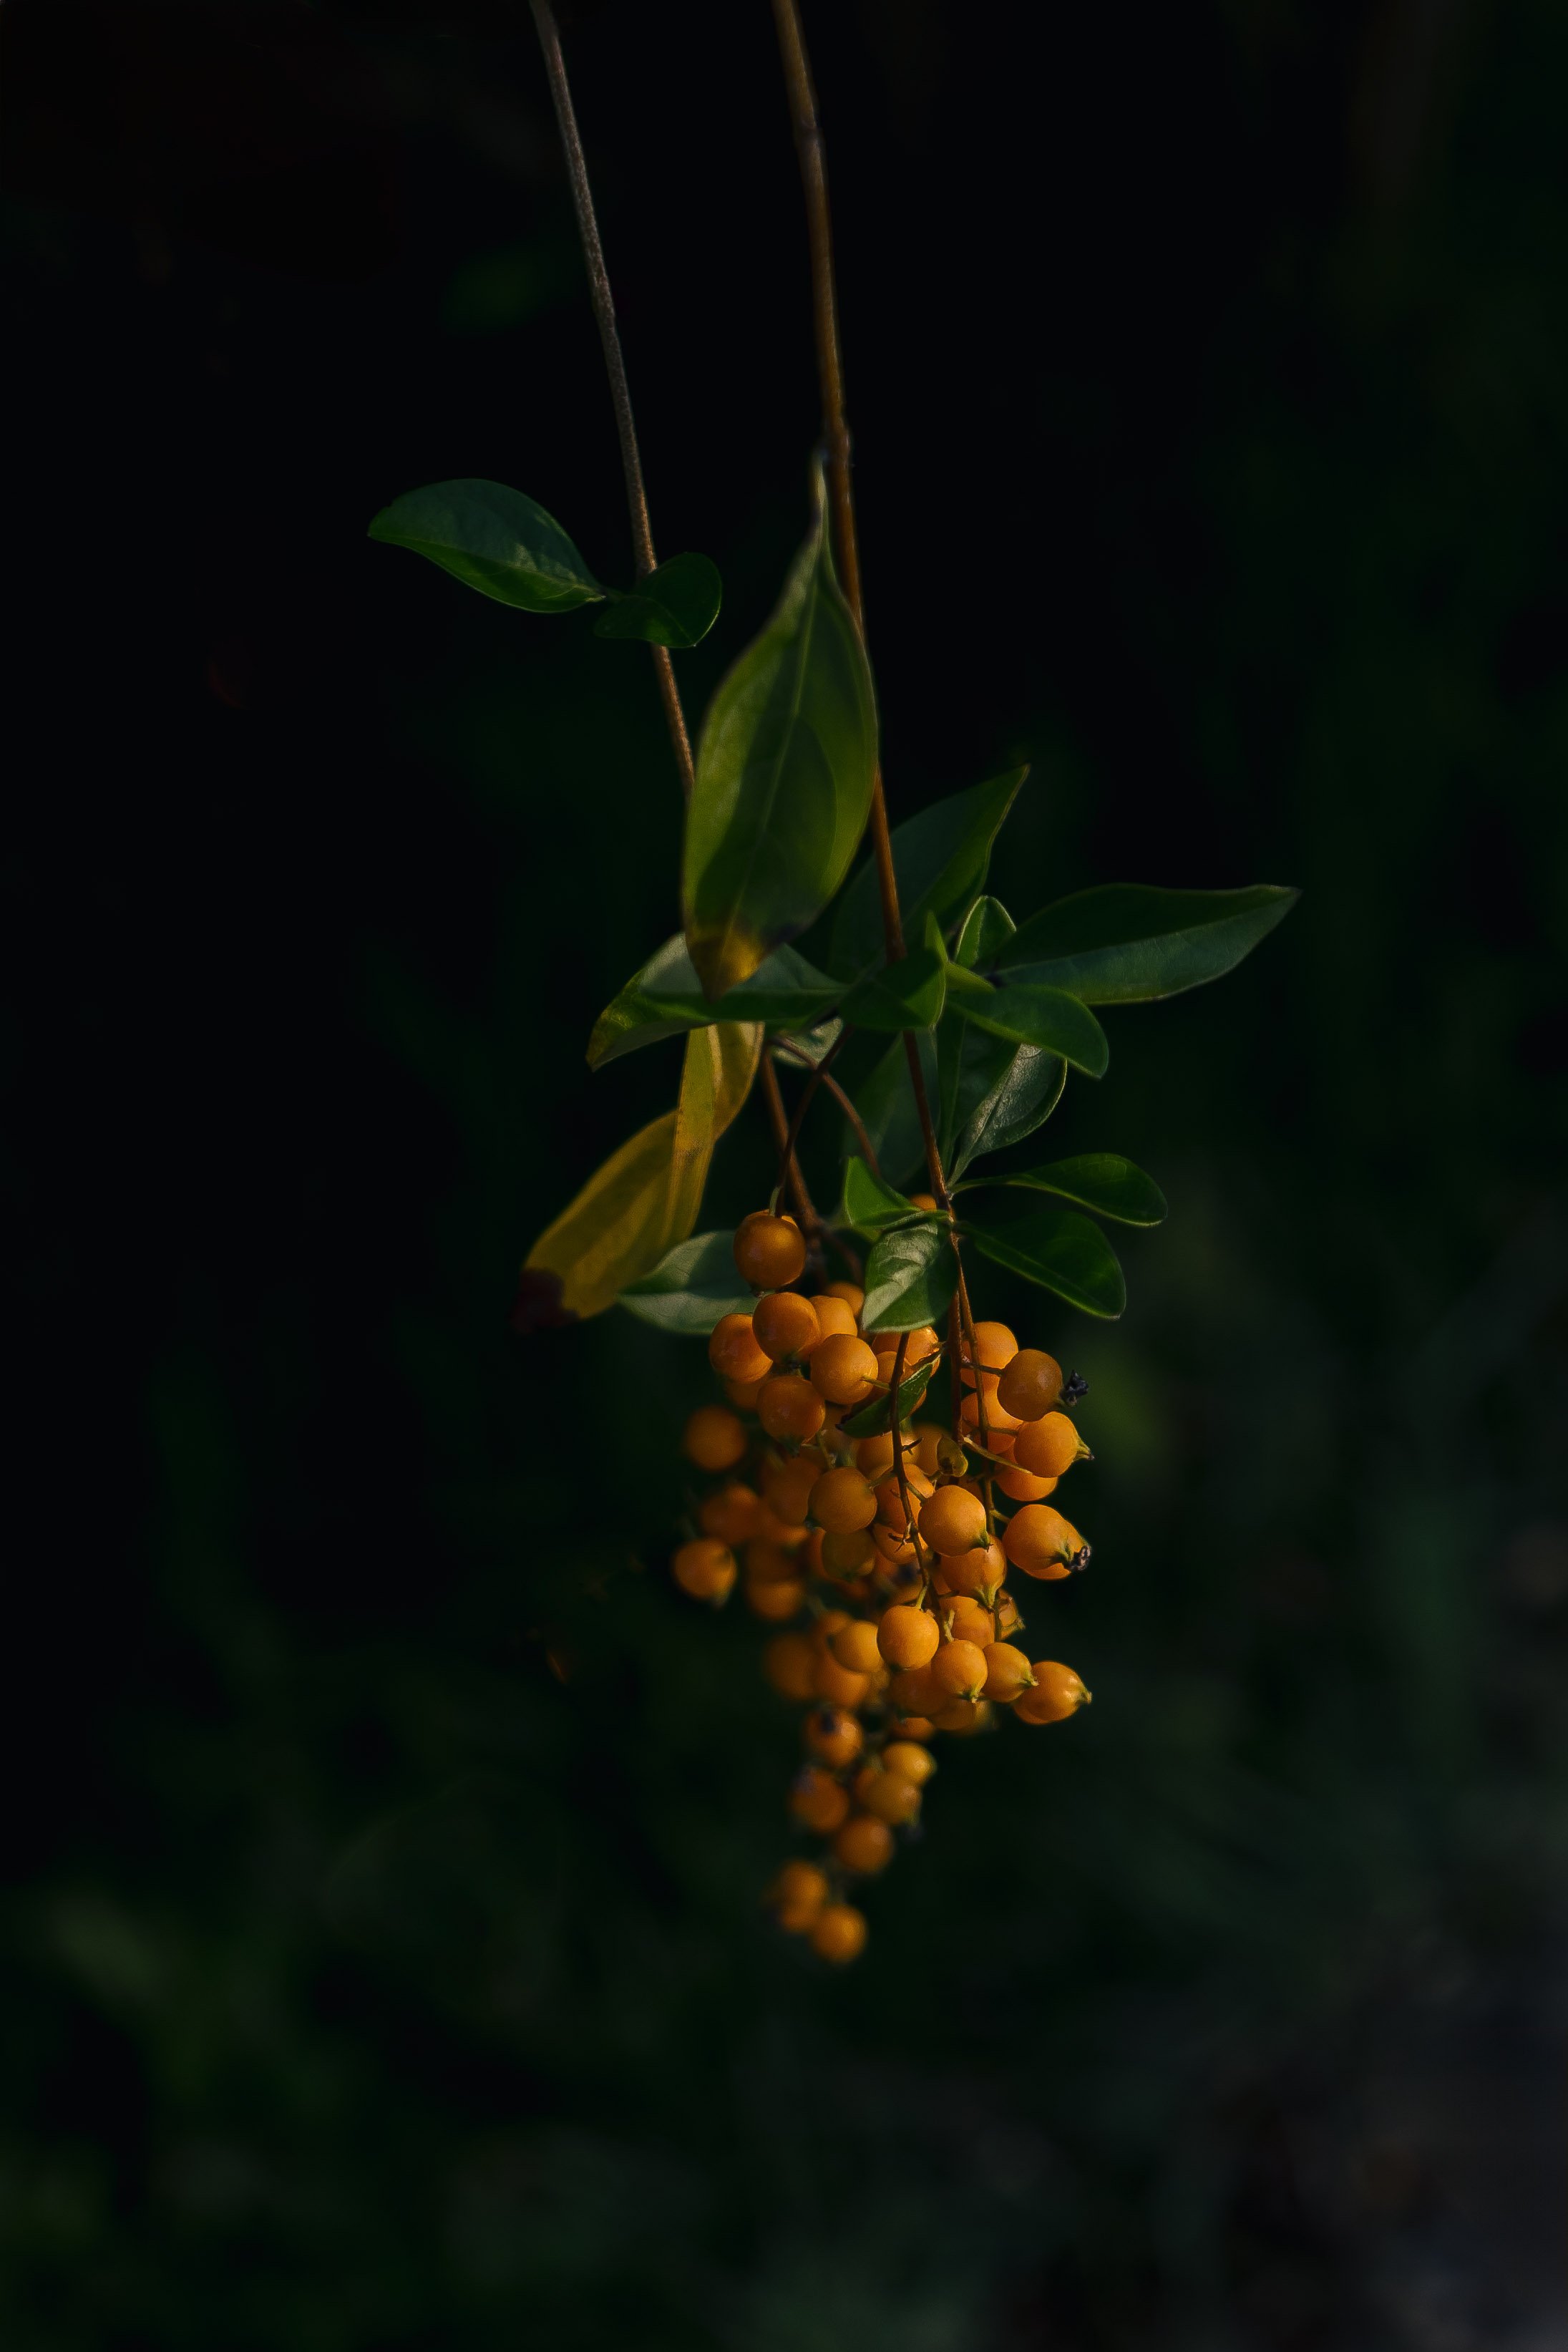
[369,480,721,647]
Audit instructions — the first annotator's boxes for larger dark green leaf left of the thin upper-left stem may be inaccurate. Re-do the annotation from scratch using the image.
[369,482,604,611]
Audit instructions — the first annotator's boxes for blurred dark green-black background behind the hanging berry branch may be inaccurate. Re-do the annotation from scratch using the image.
[0,0,1568,2352]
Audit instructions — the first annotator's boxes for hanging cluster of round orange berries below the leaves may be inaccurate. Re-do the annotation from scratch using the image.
[672,1209,1089,1962]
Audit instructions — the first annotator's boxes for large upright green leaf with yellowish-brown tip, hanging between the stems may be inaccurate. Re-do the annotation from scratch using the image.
[682,503,877,997]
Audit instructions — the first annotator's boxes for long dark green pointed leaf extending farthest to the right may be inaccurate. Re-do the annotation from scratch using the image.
[999,882,1300,1004]
